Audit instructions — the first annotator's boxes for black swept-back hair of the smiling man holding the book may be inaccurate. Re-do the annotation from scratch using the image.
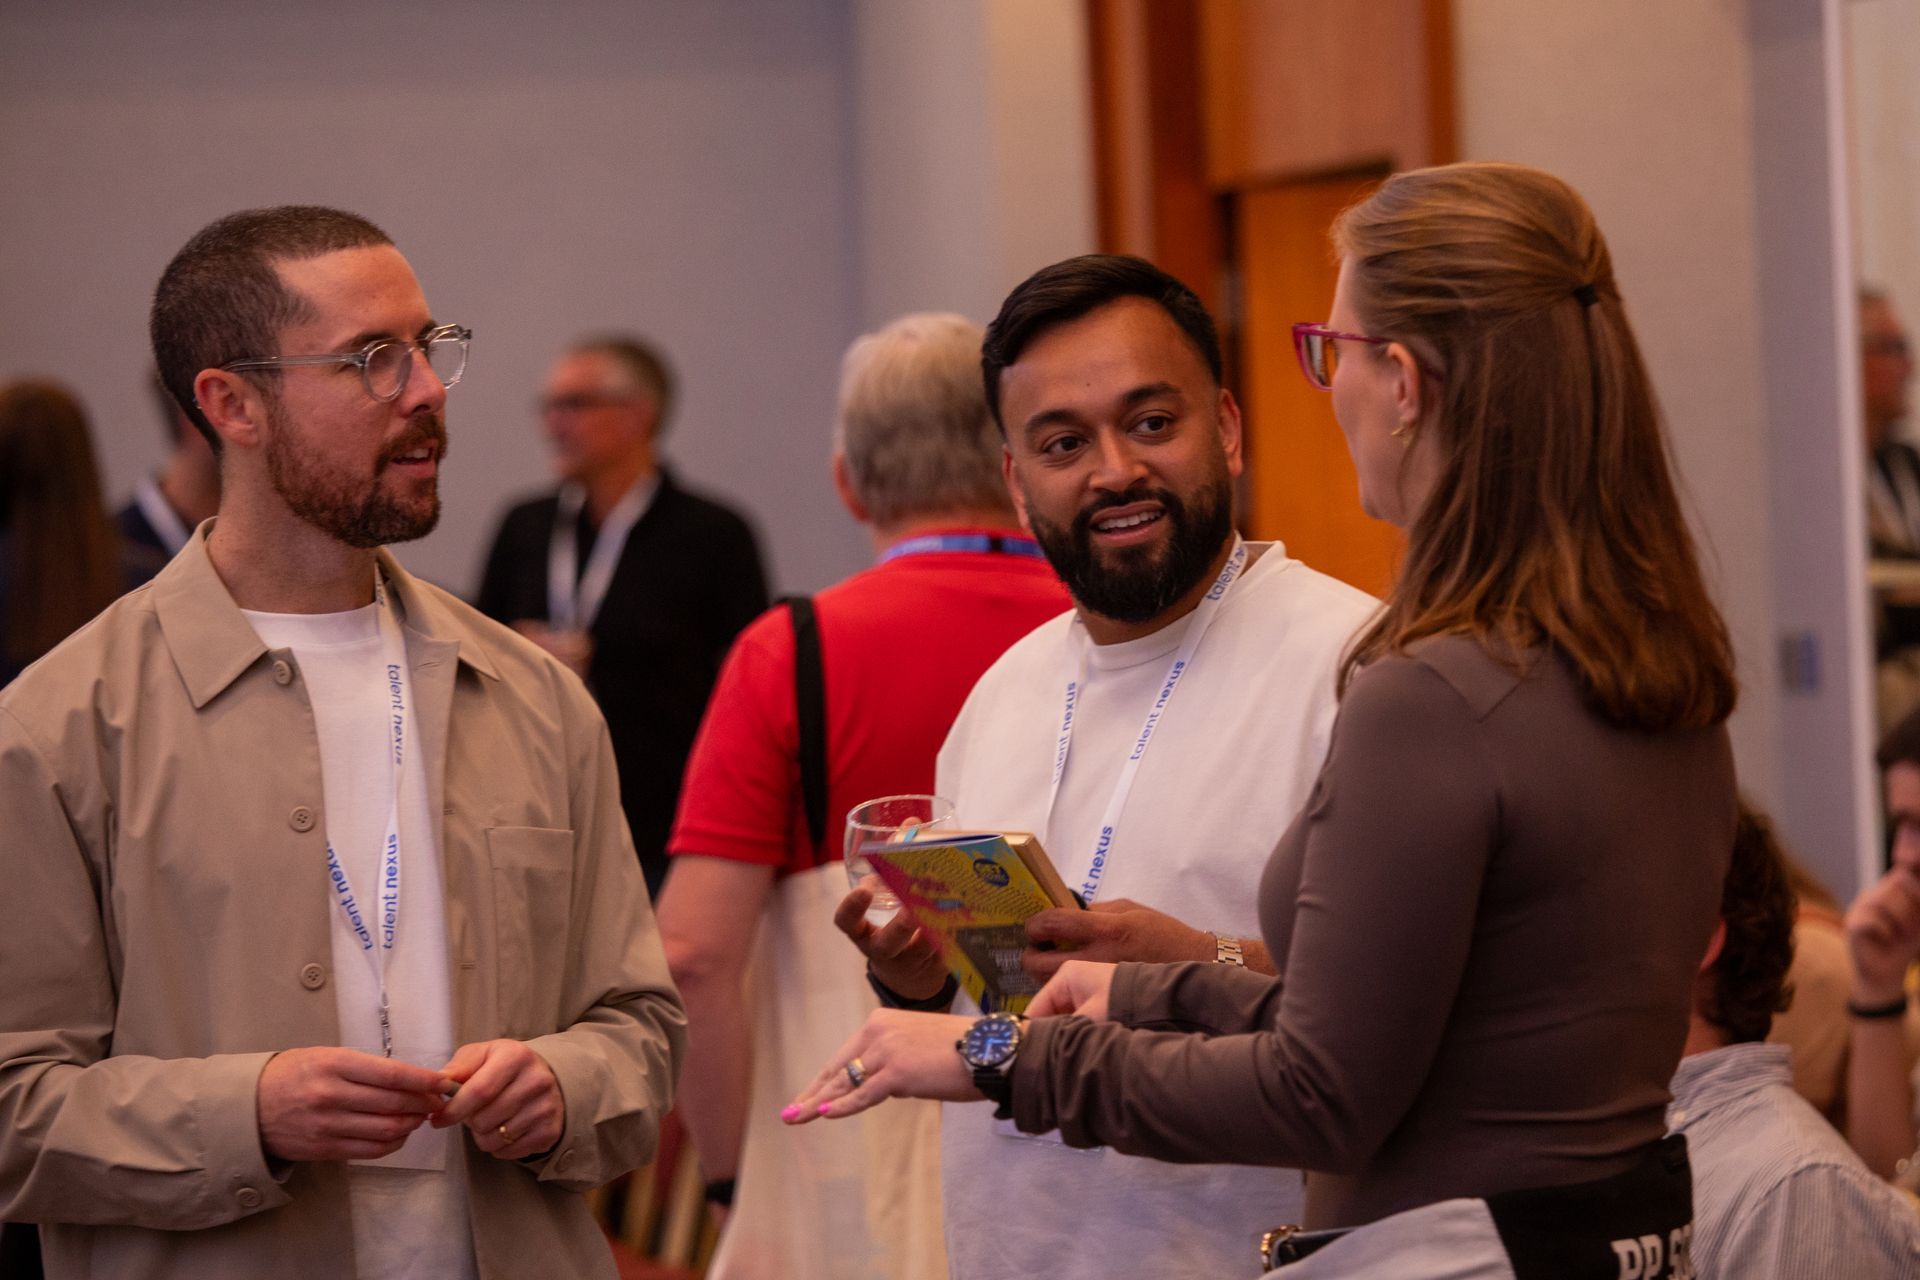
[979,253,1225,434]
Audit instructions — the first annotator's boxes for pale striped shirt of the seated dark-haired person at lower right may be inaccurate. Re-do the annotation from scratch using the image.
[1667,1044,1920,1280]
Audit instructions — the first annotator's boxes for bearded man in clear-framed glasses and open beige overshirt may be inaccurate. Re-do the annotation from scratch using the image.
[0,207,684,1278]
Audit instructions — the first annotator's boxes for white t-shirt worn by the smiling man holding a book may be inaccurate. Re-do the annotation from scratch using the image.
[935,543,1377,1280]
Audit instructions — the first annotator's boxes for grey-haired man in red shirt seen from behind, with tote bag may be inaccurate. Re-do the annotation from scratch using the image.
[659,315,1069,1280]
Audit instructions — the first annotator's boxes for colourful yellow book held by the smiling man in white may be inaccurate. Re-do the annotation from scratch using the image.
[868,831,1079,1013]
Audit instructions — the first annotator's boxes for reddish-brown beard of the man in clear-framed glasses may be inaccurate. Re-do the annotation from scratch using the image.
[267,407,447,549]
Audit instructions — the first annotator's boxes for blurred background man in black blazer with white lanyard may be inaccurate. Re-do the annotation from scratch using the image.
[476,338,766,894]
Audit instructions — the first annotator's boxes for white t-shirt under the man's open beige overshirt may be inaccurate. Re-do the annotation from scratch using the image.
[244,604,476,1280]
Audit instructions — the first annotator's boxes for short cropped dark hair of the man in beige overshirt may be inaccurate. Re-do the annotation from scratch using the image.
[148,205,394,453]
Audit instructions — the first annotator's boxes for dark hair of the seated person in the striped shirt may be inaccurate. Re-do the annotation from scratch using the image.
[1701,802,1797,1044]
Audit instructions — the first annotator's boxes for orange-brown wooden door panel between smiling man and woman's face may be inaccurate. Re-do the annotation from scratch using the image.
[1235,177,1402,595]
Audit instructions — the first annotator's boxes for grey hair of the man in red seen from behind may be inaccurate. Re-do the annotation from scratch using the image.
[833,313,1012,526]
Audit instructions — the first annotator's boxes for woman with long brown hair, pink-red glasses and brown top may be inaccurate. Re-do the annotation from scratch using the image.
[787,165,1736,1276]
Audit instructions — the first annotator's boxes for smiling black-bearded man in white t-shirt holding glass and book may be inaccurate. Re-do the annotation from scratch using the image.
[833,253,1377,1280]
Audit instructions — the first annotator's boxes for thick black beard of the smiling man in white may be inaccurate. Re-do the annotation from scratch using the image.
[1027,470,1233,622]
